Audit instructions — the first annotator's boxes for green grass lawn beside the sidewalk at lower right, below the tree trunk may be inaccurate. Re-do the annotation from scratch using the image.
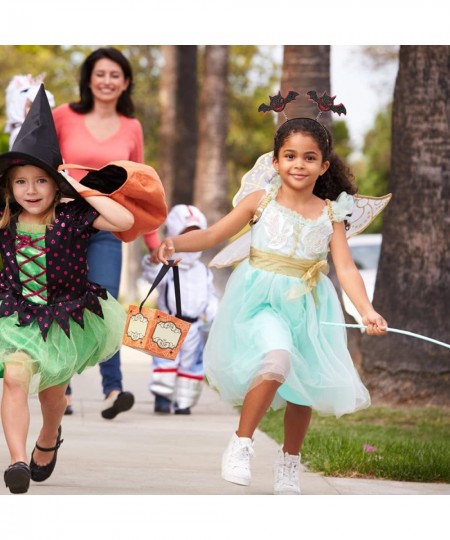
[260,406,450,483]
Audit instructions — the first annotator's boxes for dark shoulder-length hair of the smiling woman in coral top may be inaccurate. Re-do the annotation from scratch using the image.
[70,47,134,118]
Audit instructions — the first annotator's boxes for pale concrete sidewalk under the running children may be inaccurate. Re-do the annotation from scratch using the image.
[0,347,450,495]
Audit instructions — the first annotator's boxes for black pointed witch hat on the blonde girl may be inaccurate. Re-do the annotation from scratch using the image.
[0,84,80,199]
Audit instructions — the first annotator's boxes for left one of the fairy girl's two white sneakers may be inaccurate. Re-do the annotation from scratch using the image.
[222,433,255,486]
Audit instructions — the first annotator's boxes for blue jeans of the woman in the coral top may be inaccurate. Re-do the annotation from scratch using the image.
[87,231,122,396]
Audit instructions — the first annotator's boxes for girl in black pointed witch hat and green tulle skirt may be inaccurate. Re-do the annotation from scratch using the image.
[0,85,134,493]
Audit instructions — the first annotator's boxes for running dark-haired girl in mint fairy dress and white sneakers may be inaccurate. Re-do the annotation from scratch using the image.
[158,94,387,495]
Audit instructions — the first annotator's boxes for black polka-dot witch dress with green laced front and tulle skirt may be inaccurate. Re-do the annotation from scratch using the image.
[0,203,126,394]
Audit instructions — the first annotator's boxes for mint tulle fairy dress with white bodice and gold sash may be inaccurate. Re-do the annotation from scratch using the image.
[204,192,370,417]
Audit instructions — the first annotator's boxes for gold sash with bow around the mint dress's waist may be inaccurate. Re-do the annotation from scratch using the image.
[249,247,329,298]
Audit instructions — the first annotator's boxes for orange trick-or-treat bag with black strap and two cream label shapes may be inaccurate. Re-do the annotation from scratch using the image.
[122,260,191,360]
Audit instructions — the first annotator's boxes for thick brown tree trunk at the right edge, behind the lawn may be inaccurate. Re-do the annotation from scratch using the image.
[362,45,450,405]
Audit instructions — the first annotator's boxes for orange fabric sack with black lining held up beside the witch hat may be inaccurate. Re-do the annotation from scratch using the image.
[59,160,167,242]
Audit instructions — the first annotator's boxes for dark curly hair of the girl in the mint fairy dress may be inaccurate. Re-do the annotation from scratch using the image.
[273,118,357,201]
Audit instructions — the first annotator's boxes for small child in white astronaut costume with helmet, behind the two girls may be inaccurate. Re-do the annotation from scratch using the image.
[142,204,218,414]
